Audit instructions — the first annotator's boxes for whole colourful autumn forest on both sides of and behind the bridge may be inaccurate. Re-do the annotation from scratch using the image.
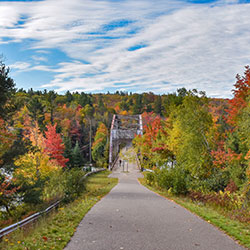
[0,62,250,227]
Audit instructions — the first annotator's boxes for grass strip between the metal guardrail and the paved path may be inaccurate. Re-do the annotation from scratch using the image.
[0,171,118,250]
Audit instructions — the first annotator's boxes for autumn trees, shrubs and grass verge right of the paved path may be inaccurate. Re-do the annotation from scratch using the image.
[134,67,250,247]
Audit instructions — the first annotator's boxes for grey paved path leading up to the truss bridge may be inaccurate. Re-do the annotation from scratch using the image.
[65,149,245,250]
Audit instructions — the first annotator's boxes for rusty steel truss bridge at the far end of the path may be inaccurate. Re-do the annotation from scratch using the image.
[109,115,143,170]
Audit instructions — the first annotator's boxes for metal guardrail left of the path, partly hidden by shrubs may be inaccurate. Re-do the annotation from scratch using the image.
[0,168,106,239]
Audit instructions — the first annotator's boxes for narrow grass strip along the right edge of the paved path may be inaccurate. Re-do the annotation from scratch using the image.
[139,178,250,249]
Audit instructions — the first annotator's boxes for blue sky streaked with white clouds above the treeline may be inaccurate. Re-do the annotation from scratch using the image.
[0,0,250,98]
